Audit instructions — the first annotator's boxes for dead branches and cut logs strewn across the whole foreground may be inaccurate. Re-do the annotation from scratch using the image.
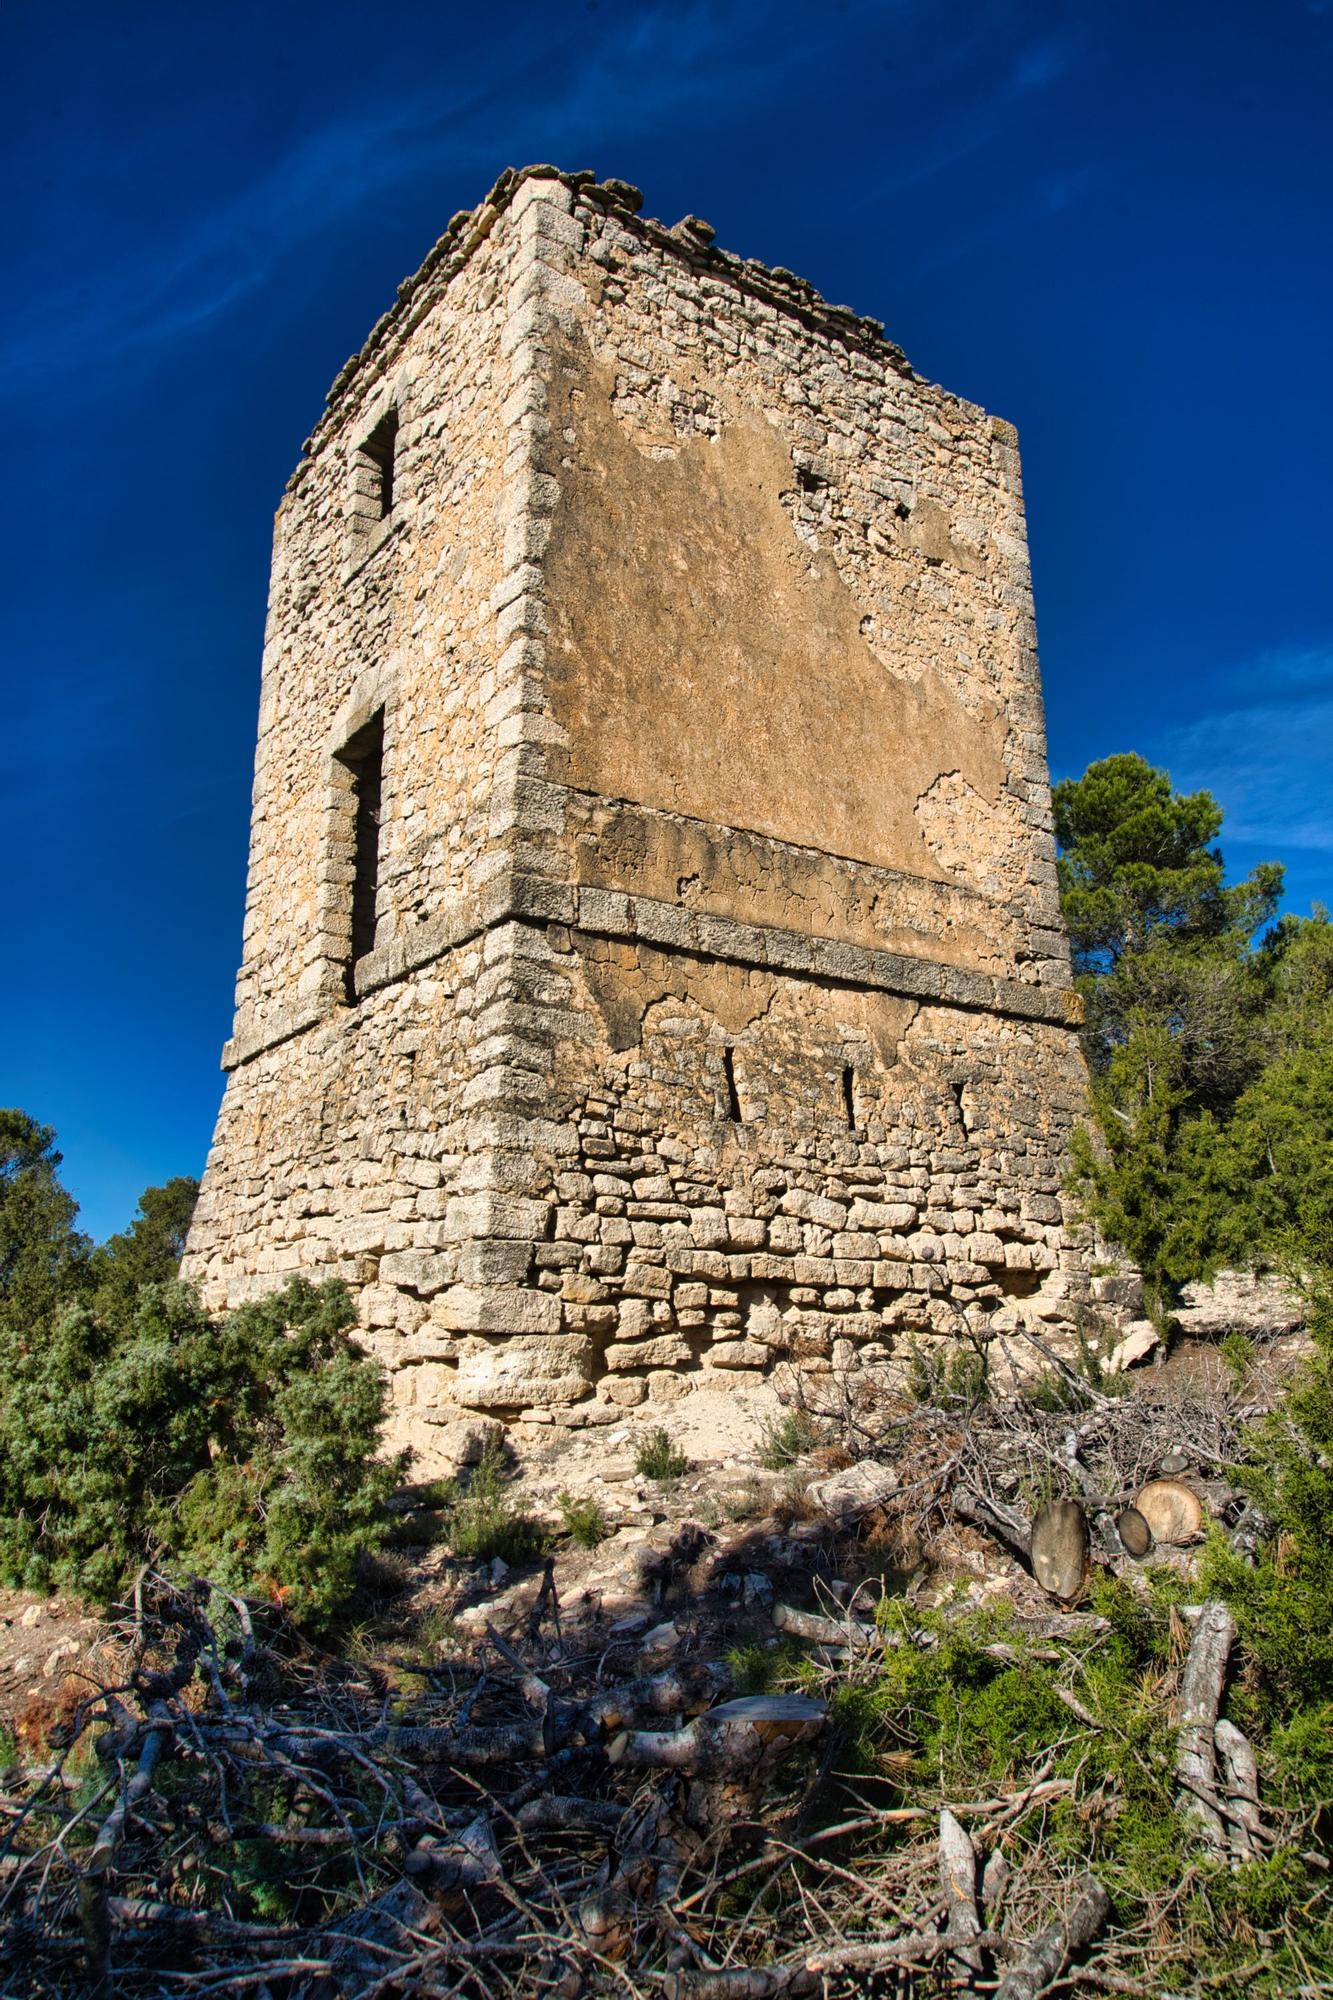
[0,1336,1329,2000]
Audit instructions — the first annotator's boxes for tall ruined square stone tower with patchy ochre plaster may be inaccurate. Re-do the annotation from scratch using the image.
[184,168,1085,1426]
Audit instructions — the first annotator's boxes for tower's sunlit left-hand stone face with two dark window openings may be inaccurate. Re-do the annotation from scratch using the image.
[184,180,544,1330]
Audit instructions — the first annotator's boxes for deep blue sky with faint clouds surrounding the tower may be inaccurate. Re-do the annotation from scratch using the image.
[0,0,1333,1236]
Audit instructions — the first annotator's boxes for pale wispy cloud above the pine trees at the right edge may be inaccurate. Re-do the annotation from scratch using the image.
[1153,644,1333,860]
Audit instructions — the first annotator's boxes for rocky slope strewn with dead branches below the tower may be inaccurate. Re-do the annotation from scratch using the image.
[0,1288,1327,2000]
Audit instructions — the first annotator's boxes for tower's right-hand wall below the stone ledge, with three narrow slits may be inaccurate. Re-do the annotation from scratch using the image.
[426,926,1087,1424]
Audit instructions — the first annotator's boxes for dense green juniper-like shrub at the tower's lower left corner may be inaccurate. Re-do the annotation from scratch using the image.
[0,1278,402,1626]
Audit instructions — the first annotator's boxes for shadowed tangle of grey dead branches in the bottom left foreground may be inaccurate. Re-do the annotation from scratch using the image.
[0,1572,1128,2000]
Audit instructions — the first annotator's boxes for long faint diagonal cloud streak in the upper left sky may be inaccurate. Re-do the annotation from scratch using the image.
[0,0,896,398]
